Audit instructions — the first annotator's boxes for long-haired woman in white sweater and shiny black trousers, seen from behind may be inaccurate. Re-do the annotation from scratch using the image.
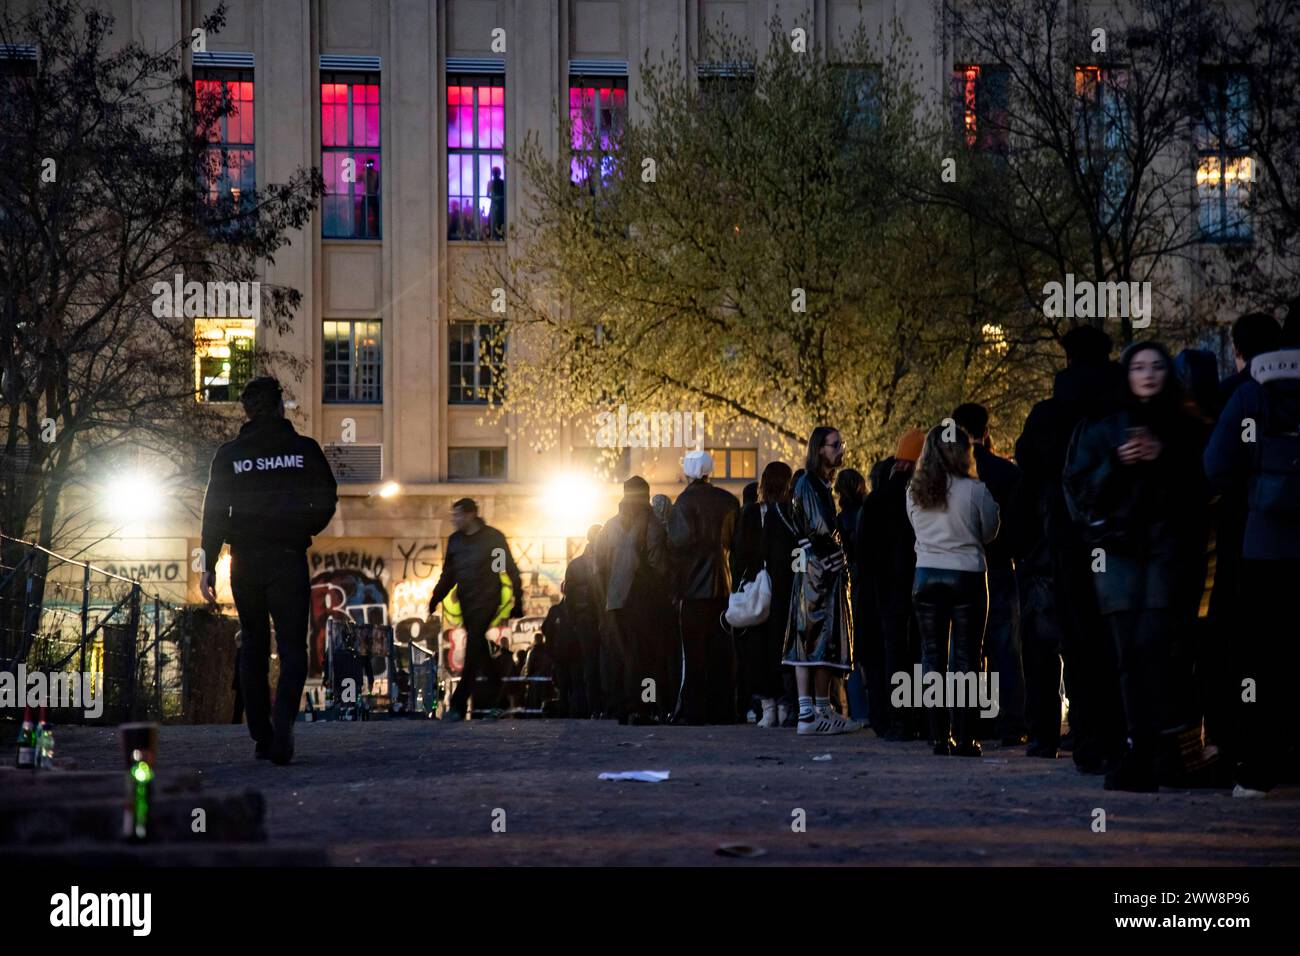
[907,421,998,757]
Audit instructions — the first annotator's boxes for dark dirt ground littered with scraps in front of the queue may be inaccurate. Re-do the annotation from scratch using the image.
[43,719,1300,866]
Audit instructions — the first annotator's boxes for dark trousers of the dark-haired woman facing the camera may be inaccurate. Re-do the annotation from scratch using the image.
[1106,607,1174,761]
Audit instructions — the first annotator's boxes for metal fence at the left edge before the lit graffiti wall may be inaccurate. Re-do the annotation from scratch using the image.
[0,535,185,723]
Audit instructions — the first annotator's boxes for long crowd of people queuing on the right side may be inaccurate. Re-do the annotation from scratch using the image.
[488,310,1300,796]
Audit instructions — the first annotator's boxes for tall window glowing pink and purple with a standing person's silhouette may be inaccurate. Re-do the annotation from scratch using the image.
[447,75,506,239]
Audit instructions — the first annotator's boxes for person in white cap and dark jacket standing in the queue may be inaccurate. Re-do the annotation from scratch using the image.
[668,449,740,724]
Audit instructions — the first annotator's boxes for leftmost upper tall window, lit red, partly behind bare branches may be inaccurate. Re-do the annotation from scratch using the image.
[194,70,257,208]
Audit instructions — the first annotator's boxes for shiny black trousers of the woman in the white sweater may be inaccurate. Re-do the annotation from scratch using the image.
[911,567,988,744]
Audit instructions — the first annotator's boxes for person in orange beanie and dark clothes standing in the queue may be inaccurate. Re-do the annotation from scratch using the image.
[855,428,926,740]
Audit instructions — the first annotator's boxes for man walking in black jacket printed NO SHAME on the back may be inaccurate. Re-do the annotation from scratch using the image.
[199,376,338,765]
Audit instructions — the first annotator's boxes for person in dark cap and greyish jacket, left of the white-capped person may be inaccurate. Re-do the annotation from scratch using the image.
[595,475,670,723]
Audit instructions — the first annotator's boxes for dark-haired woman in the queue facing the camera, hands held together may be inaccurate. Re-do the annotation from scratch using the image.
[1065,342,1209,792]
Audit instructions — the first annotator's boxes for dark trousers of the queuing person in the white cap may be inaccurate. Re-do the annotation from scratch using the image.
[676,597,736,723]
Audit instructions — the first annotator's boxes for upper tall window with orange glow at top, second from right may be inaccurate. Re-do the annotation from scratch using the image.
[1074,66,1131,222]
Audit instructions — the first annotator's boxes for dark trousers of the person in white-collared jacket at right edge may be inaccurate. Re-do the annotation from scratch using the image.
[1235,559,1300,790]
